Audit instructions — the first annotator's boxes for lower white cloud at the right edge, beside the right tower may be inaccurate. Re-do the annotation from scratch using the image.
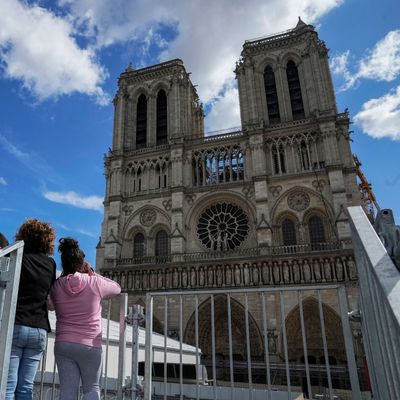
[354,86,400,140]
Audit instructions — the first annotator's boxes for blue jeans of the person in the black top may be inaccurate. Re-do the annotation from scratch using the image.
[6,325,47,400]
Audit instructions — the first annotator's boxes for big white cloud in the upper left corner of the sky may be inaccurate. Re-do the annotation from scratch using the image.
[0,0,108,104]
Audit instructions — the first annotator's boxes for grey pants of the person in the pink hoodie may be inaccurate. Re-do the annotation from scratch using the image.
[54,342,102,400]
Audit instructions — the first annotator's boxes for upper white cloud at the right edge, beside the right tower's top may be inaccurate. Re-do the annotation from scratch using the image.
[331,30,400,90]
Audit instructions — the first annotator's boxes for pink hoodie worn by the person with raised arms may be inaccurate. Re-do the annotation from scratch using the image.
[49,272,121,347]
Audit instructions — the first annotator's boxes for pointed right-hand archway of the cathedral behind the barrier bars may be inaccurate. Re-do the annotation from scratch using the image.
[286,297,346,364]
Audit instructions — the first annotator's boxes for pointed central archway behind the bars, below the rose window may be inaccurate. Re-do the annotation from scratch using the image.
[184,295,264,360]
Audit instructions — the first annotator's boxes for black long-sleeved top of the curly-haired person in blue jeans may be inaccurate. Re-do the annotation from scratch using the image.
[15,252,56,332]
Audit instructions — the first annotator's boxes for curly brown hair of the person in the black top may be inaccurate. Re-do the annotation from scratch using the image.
[15,218,56,255]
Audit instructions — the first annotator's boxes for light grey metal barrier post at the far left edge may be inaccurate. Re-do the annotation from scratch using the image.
[0,241,24,399]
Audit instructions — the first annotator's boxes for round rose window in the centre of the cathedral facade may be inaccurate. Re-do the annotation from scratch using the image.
[197,203,249,250]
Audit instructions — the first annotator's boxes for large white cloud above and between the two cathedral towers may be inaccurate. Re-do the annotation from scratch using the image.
[59,0,343,129]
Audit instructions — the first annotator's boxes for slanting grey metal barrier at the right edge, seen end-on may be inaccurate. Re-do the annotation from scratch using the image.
[348,207,400,400]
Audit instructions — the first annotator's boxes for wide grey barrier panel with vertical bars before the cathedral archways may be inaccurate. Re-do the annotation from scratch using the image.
[144,285,362,400]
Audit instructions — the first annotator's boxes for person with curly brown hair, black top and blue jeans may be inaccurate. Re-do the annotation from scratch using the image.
[6,219,56,400]
